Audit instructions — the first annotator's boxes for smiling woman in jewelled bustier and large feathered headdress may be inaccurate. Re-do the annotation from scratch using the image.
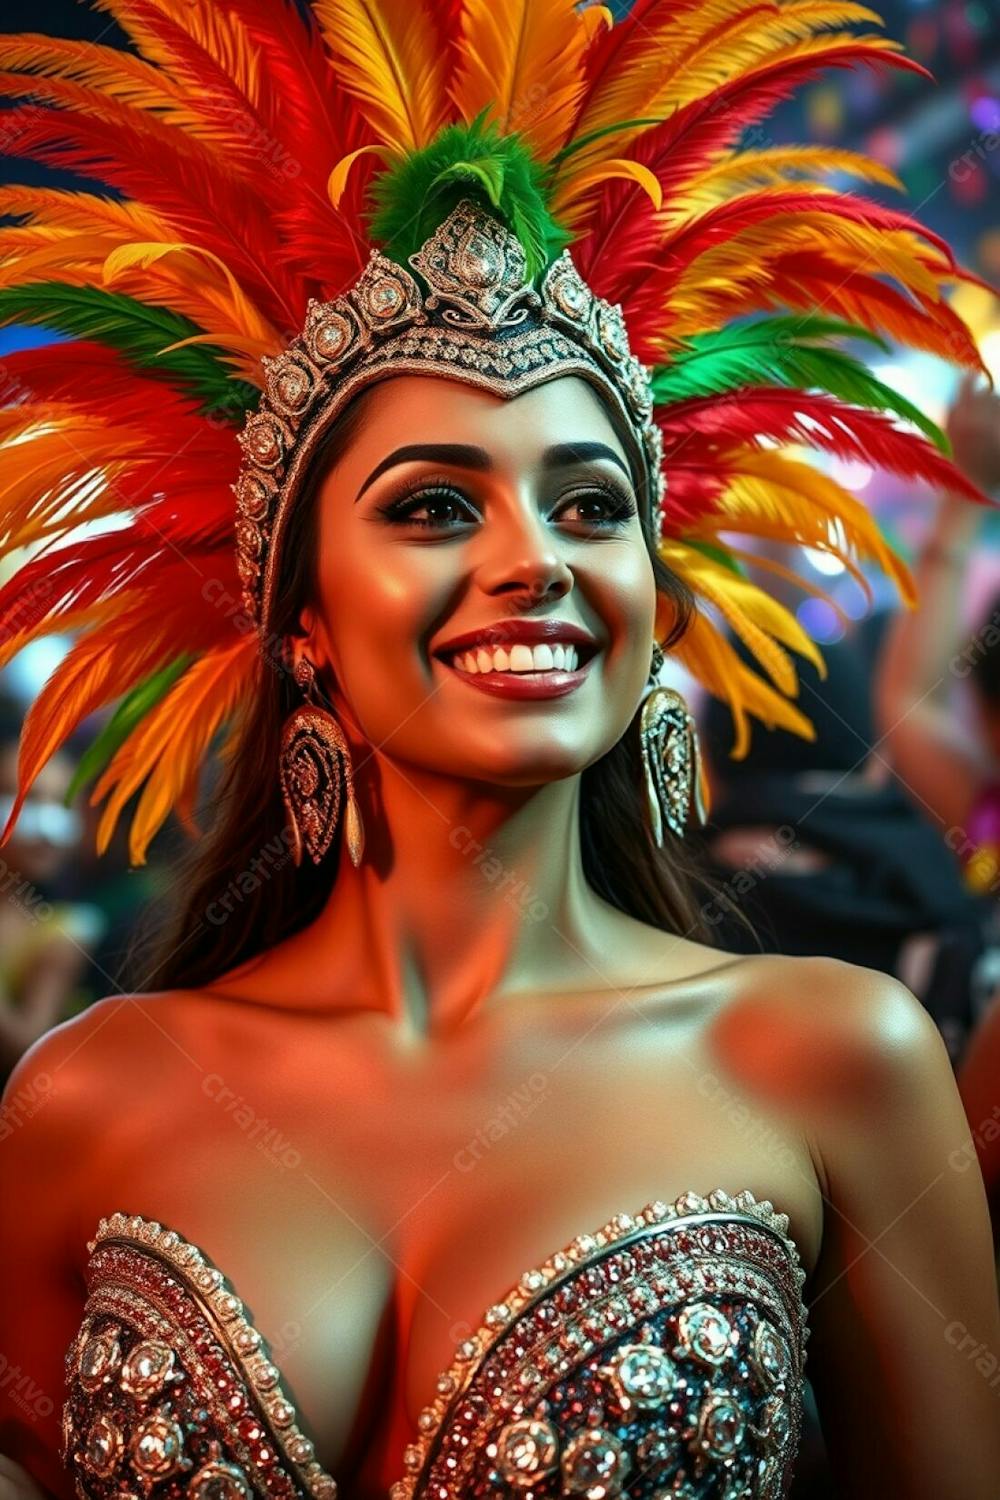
[0,0,1000,1500]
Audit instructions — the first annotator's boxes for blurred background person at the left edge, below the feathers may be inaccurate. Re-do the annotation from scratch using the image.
[0,702,103,1080]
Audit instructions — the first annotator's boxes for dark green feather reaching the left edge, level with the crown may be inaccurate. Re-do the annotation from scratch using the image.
[0,282,259,422]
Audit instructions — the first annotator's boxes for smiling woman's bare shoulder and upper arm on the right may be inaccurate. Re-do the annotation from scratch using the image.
[807,960,1000,1500]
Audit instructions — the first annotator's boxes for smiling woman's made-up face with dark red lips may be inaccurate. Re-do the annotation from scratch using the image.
[300,375,670,786]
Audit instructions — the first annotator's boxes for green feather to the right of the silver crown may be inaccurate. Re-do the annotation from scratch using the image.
[652,314,951,456]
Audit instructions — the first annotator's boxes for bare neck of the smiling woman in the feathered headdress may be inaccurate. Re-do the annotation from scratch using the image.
[226,759,625,1040]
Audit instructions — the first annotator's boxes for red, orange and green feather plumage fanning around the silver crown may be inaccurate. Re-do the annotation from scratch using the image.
[0,0,984,863]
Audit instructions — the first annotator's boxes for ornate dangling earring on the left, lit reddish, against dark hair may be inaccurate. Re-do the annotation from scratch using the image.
[279,657,364,869]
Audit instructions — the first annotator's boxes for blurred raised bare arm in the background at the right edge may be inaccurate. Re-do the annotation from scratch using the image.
[876,378,1000,828]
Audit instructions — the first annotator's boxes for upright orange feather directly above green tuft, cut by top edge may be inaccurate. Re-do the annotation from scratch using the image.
[450,0,595,161]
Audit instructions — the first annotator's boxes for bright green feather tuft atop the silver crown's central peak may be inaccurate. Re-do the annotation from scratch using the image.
[369,105,573,279]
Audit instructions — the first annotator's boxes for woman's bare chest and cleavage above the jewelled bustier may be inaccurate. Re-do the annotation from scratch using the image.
[68,996,819,1497]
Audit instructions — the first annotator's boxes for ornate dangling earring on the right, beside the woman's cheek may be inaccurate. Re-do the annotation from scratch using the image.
[639,642,705,849]
